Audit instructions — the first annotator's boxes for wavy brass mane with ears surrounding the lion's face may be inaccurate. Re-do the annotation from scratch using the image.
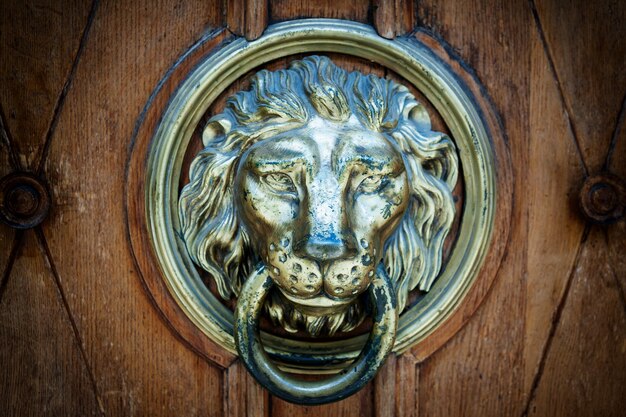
[179,56,458,330]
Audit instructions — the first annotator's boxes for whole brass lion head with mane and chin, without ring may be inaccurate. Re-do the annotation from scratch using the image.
[180,56,457,335]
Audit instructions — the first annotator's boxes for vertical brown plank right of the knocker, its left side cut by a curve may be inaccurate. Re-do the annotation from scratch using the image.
[414,0,531,416]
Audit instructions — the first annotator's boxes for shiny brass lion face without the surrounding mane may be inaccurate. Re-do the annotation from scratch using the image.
[236,117,409,315]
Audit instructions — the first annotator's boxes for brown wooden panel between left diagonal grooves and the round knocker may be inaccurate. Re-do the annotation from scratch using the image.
[39,1,222,416]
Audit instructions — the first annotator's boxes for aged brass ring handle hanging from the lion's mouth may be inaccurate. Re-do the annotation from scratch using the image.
[235,264,398,405]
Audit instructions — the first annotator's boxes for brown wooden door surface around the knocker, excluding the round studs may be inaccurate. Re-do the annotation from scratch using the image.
[0,0,626,417]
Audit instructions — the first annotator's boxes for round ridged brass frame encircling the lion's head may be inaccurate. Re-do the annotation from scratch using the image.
[144,19,498,371]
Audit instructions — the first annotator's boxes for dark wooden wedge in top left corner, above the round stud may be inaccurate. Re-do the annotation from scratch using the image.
[0,0,91,170]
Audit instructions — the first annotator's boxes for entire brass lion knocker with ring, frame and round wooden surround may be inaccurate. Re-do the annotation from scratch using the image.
[126,19,511,404]
